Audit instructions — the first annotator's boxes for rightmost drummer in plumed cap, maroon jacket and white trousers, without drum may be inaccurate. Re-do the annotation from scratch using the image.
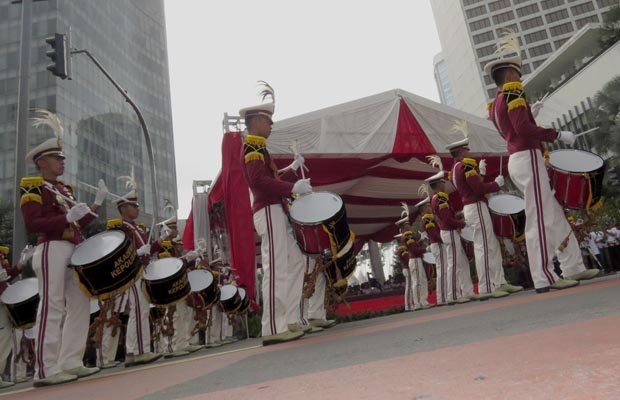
[484,31,600,293]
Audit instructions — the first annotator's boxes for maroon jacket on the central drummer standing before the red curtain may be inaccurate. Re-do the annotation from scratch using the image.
[243,135,294,212]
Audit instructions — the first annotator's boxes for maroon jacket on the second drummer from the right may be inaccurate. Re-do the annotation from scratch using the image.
[452,158,500,205]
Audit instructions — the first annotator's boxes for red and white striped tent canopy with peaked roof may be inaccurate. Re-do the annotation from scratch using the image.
[267,89,507,242]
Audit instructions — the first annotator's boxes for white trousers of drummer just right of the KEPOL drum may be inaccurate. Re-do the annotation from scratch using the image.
[125,278,151,355]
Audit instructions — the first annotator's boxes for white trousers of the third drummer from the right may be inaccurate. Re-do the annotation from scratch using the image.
[440,231,474,300]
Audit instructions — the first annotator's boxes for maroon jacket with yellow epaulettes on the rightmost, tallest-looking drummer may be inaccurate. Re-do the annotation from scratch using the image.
[489,82,558,154]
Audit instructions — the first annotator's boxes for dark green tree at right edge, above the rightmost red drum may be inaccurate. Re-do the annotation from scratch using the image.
[592,75,620,155]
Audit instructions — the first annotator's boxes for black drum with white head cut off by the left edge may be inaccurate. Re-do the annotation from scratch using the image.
[0,278,39,329]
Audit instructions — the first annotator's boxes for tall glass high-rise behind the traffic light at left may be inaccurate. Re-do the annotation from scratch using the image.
[0,0,177,222]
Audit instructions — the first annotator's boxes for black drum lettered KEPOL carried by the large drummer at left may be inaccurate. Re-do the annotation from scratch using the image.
[70,230,142,300]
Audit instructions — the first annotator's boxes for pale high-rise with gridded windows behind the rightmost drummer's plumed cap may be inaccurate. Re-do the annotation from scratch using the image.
[431,0,614,114]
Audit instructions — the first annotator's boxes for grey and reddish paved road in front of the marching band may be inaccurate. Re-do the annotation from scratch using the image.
[0,275,620,400]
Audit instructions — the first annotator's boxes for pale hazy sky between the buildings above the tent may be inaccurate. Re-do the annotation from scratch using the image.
[165,0,440,219]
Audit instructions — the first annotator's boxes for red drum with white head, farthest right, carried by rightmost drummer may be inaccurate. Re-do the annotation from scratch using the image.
[548,149,605,210]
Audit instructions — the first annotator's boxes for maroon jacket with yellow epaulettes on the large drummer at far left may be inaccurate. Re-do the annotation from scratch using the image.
[20,177,95,244]
